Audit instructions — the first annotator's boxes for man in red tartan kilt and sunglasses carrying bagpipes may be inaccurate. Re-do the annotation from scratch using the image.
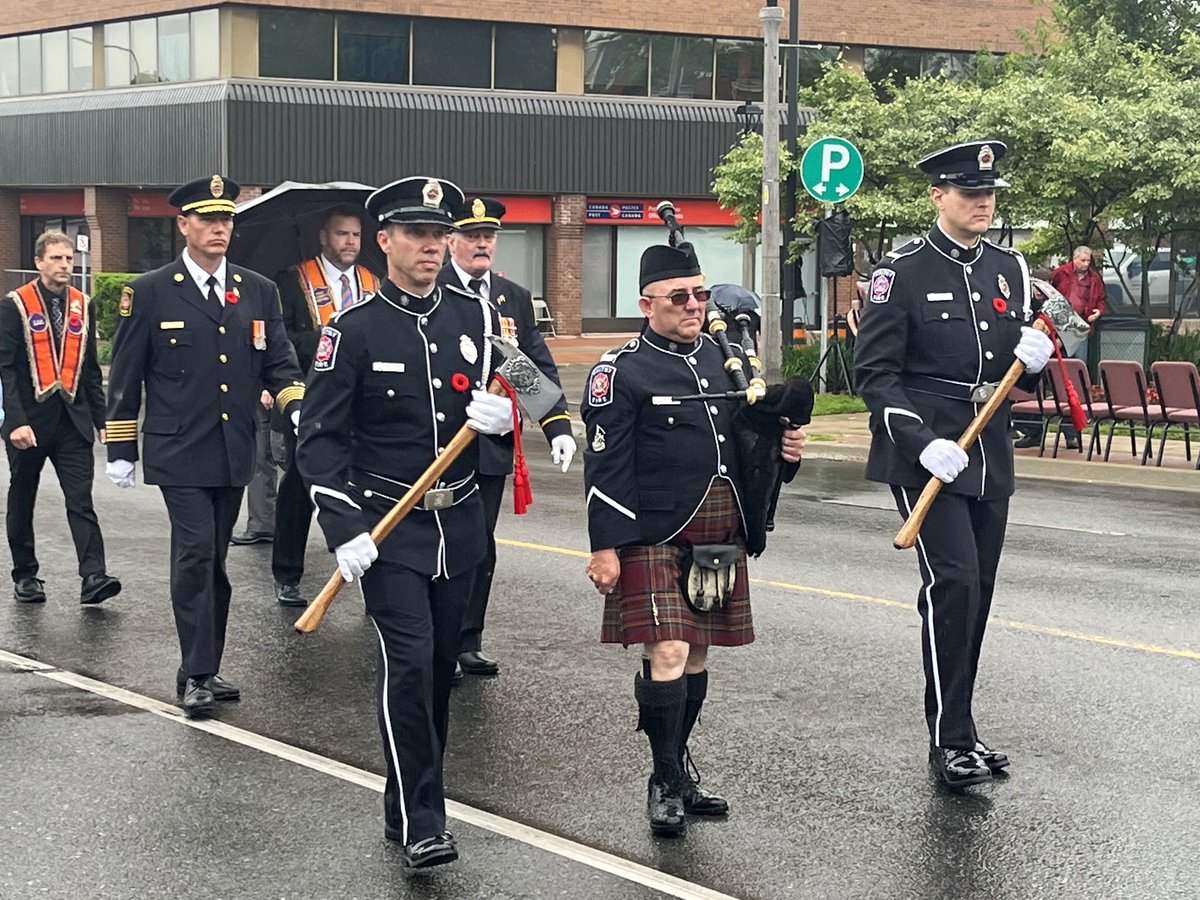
[581,244,805,836]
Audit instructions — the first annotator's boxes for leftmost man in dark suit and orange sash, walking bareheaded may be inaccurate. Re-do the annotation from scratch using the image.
[0,232,121,604]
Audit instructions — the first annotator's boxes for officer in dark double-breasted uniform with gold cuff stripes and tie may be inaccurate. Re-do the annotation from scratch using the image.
[107,175,304,716]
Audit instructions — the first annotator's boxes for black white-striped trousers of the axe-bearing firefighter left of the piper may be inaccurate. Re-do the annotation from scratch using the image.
[362,562,472,844]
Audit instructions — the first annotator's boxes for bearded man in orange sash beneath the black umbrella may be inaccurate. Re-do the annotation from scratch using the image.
[271,205,379,606]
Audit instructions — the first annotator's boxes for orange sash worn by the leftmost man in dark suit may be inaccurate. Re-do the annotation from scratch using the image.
[12,281,90,403]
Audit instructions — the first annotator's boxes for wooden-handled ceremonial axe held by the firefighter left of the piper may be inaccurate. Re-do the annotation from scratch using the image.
[294,335,563,634]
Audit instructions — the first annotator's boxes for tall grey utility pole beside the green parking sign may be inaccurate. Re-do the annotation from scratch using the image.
[758,0,784,383]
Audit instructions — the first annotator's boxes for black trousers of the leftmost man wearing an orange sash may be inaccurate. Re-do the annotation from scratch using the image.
[5,417,104,581]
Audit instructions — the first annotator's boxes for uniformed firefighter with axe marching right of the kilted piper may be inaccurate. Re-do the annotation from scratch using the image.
[854,140,1054,786]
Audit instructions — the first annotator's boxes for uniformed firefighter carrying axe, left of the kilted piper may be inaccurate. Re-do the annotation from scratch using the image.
[296,176,512,868]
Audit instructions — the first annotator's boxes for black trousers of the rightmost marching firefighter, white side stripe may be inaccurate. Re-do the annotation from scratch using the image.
[892,486,1008,749]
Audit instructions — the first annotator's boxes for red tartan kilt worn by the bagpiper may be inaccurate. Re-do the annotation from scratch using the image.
[600,479,754,647]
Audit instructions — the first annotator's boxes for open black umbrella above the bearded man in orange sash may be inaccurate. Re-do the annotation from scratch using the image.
[226,181,388,278]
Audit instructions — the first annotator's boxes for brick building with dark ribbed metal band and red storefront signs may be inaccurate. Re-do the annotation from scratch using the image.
[0,0,1044,334]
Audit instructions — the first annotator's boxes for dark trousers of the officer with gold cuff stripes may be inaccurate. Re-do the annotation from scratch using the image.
[161,485,245,678]
